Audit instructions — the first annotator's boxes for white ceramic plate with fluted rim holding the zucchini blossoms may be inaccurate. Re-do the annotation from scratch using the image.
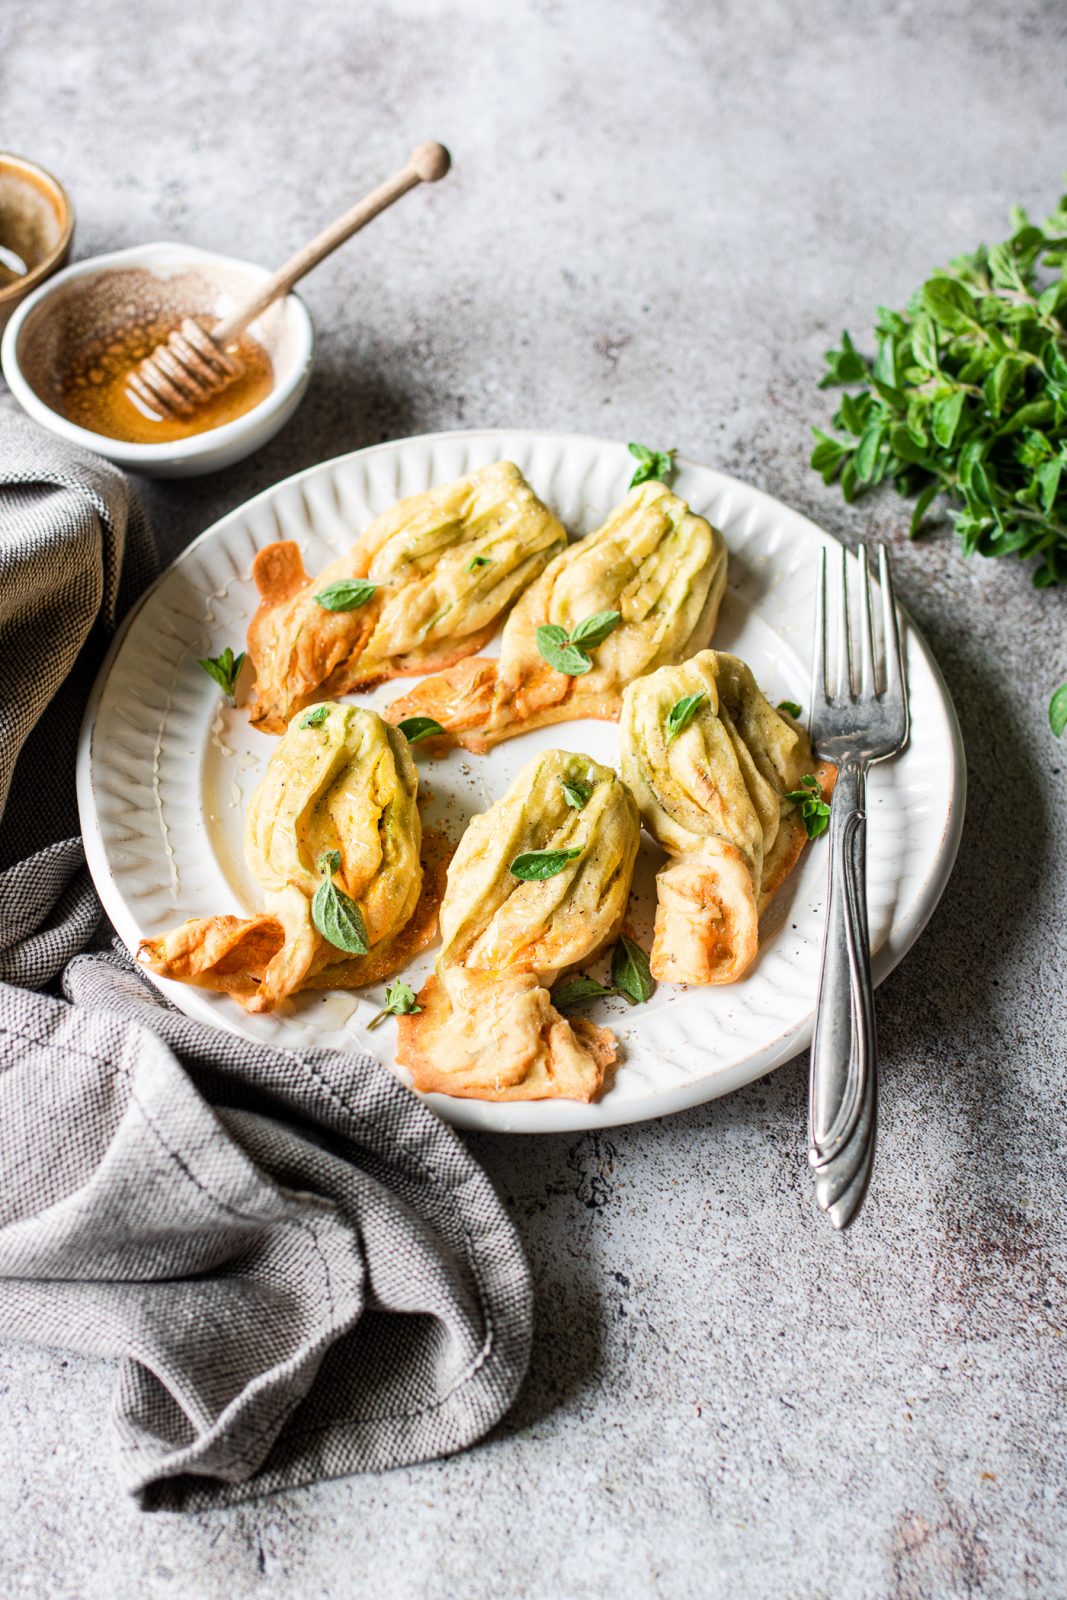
[78,430,965,1133]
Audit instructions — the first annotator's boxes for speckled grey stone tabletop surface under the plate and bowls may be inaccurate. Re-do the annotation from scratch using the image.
[0,0,1067,1600]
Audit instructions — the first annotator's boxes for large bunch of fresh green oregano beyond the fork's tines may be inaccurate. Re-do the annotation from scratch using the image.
[811,195,1067,589]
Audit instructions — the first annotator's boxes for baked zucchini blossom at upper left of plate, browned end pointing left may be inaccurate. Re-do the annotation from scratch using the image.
[248,461,566,733]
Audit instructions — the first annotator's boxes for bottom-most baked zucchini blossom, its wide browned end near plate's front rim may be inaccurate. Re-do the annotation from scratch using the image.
[397,750,640,1101]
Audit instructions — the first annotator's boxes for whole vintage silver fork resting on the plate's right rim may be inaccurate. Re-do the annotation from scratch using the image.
[808,546,907,1229]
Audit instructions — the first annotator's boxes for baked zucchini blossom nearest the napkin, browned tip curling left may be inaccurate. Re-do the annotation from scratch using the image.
[138,704,437,1011]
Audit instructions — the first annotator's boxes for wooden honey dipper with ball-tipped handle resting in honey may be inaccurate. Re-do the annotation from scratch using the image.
[126,144,451,419]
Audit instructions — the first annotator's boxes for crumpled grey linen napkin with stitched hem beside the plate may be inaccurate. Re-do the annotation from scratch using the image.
[0,413,533,1510]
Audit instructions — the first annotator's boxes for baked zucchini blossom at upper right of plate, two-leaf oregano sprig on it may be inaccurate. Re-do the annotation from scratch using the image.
[386,482,726,752]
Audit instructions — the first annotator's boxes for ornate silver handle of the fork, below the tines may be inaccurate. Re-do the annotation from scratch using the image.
[808,758,877,1229]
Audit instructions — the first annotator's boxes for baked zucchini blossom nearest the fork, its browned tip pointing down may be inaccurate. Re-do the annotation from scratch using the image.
[619,650,835,984]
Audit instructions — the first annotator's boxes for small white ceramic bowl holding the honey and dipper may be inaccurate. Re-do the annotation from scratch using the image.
[0,242,315,478]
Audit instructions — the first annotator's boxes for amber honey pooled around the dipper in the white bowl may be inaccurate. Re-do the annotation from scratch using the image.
[45,304,274,445]
